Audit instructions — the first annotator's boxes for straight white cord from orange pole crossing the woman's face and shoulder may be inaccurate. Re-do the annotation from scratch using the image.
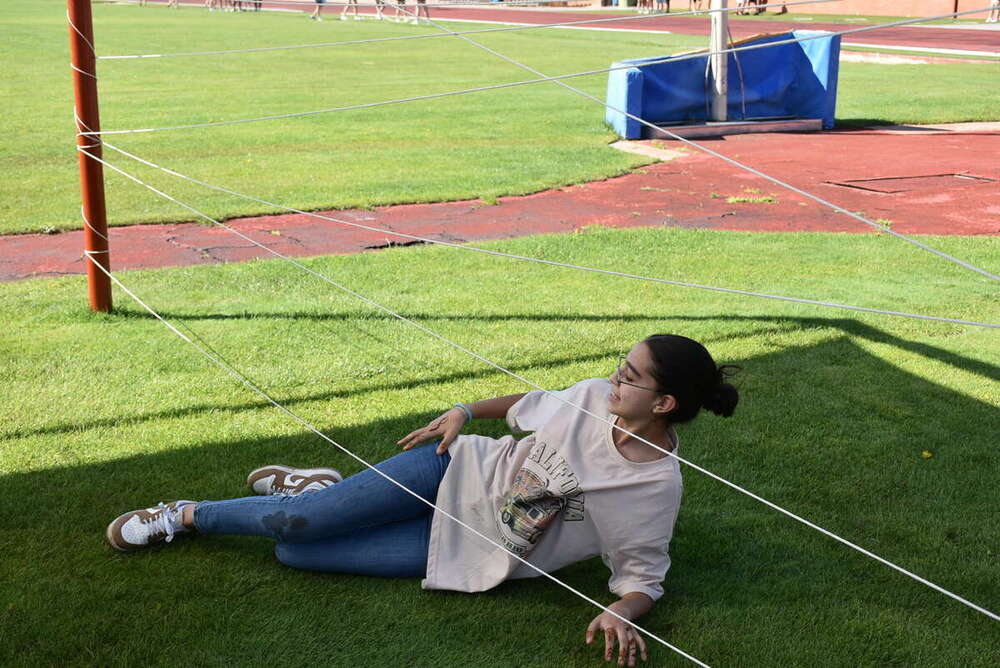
[78,145,1000,620]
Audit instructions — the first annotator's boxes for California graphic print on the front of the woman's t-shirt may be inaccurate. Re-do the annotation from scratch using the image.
[496,443,584,556]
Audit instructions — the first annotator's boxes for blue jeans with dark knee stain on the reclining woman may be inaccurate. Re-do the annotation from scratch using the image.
[194,443,451,577]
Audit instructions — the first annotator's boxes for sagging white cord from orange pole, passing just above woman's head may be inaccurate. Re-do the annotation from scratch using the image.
[103,142,1000,329]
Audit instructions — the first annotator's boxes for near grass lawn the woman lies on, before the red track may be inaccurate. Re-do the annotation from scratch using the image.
[0,228,1000,668]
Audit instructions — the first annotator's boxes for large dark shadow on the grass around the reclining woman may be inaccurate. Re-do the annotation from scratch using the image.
[0,336,1000,666]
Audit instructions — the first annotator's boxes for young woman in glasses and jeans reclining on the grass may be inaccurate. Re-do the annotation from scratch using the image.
[106,335,738,666]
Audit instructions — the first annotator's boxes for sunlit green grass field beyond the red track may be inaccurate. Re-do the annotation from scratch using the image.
[0,0,1000,233]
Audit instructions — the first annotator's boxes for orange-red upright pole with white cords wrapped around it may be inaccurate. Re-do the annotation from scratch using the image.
[66,0,111,312]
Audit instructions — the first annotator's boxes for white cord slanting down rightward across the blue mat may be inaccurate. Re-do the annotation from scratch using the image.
[412,1,1000,283]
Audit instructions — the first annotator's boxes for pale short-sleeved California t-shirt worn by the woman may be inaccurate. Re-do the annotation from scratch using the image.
[423,379,682,600]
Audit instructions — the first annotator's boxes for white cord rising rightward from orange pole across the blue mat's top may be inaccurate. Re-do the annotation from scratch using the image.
[81,7,989,135]
